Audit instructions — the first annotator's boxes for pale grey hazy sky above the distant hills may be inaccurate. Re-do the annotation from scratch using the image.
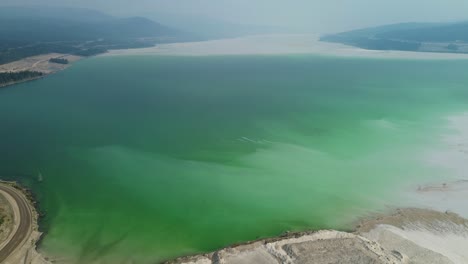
[0,0,468,33]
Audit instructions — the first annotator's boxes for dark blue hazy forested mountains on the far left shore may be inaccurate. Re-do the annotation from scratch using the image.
[0,7,196,64]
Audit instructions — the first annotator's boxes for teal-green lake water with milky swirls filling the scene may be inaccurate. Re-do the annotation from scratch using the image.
[0,56,468,263]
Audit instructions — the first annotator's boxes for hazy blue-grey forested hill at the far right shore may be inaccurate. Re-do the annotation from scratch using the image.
[321,22,468,53]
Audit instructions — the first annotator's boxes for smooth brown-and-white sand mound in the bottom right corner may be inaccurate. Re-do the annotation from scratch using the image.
[357,209,468,264]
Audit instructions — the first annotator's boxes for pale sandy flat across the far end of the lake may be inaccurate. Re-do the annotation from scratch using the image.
[106,35,468,59]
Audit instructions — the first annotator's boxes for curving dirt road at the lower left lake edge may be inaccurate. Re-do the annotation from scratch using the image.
[0,184,33,263]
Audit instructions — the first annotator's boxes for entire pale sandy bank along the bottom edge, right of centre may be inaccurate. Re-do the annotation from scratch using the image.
[167,209,468,264]
